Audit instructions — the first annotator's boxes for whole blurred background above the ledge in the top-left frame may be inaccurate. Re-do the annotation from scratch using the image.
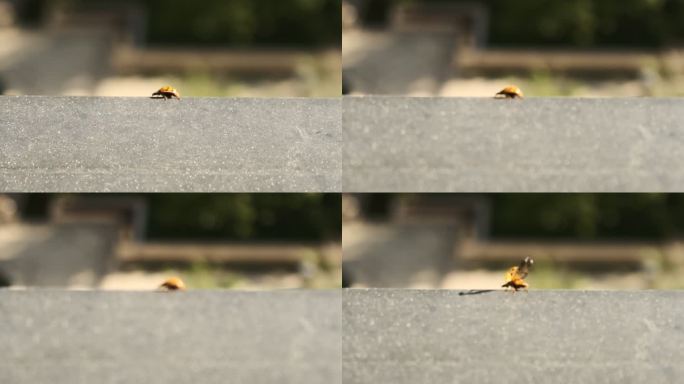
[0,0,341,97]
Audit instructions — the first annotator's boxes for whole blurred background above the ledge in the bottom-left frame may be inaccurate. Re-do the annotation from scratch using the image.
[0,194,342,290]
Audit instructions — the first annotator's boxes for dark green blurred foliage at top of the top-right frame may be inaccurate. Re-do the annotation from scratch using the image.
[384,0,684,48]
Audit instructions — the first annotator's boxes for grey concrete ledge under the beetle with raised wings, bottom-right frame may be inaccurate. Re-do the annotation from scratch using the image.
[342,289,684,384]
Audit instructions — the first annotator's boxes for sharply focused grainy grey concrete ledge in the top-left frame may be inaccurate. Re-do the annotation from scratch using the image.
[0,96,341,192]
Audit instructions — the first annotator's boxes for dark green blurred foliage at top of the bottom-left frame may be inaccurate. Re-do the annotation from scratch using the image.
[147,193,341,241]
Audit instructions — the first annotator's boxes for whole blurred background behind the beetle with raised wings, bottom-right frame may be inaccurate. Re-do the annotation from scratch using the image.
[342,193,684,289]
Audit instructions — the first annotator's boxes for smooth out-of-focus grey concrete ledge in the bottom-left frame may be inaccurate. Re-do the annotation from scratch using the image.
[0,291,341,384]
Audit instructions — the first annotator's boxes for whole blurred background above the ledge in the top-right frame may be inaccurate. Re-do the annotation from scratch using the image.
[342,0,684,97]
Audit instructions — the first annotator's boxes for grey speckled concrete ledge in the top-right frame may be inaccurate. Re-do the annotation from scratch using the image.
[342,97,684,192]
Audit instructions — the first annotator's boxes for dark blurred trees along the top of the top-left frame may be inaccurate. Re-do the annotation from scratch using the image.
[60,0,342,47]
